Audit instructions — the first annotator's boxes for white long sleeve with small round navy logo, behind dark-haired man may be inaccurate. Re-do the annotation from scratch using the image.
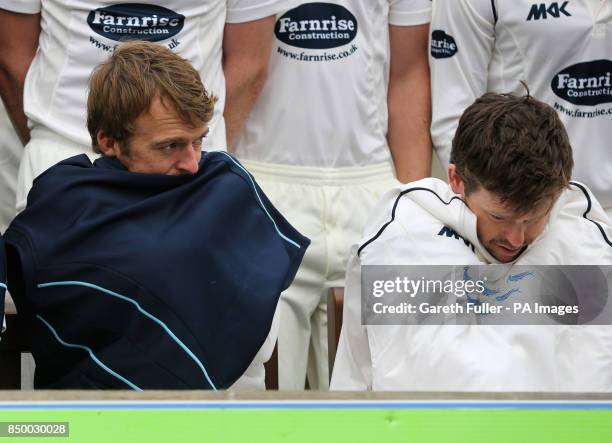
[429,0,496,166]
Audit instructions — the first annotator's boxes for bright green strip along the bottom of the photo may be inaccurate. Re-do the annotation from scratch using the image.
[0,409,612,443]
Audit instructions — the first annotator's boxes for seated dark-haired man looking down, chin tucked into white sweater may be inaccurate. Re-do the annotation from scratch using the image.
[331,93,612,392]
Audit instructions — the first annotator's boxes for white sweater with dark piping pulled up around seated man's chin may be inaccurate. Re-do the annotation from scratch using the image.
[331,178,612,392]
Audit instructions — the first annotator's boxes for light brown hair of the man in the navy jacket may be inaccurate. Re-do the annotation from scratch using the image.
[87,41,217,153]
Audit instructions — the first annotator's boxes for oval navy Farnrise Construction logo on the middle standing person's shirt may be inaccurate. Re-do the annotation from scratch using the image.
[274,3,357,49]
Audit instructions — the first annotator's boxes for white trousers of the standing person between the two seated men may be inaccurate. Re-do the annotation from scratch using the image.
[242,161,397,390]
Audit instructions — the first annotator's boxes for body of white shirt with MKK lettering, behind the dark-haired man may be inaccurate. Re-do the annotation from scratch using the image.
[490,0,612,207]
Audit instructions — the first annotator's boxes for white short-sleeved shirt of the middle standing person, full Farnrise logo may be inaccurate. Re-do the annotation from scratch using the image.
[236,0,431,168]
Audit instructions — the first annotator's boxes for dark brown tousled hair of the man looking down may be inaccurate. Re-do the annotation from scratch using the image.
[450,93,574,213]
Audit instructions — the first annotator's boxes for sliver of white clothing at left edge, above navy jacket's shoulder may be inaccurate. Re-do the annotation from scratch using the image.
[0,100,23,233]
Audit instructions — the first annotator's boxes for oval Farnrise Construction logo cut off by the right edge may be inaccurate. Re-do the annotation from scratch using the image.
[550,60,612,106]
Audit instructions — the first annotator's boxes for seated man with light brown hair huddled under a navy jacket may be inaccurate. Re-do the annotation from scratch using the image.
[6,42,309,390]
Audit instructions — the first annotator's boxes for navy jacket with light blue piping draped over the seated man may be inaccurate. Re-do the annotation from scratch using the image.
[5,152,309,389]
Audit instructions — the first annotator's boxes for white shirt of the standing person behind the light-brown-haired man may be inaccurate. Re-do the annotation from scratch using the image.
[0,0,287,151]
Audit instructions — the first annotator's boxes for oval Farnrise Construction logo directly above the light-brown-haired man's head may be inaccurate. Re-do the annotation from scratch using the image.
[87,3,185,42]
